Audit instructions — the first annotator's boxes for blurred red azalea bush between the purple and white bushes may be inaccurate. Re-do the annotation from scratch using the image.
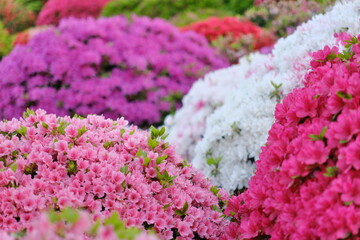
[182,17,274,63]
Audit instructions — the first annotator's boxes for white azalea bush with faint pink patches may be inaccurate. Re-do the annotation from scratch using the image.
[166,1,360,190]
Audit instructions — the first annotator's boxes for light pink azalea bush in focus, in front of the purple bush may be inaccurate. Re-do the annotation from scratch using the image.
[0,110,228,239]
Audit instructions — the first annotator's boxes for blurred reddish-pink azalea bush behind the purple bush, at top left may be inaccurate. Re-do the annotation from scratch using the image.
[36,0,109,25]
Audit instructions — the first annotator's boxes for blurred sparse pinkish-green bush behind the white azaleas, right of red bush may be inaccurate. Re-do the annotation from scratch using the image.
[245,0,334,37]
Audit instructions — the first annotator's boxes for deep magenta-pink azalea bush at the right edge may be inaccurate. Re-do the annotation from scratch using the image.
[226,34,360,240]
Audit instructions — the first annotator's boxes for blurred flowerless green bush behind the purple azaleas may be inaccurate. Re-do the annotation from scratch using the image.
[102,0,224,19]
